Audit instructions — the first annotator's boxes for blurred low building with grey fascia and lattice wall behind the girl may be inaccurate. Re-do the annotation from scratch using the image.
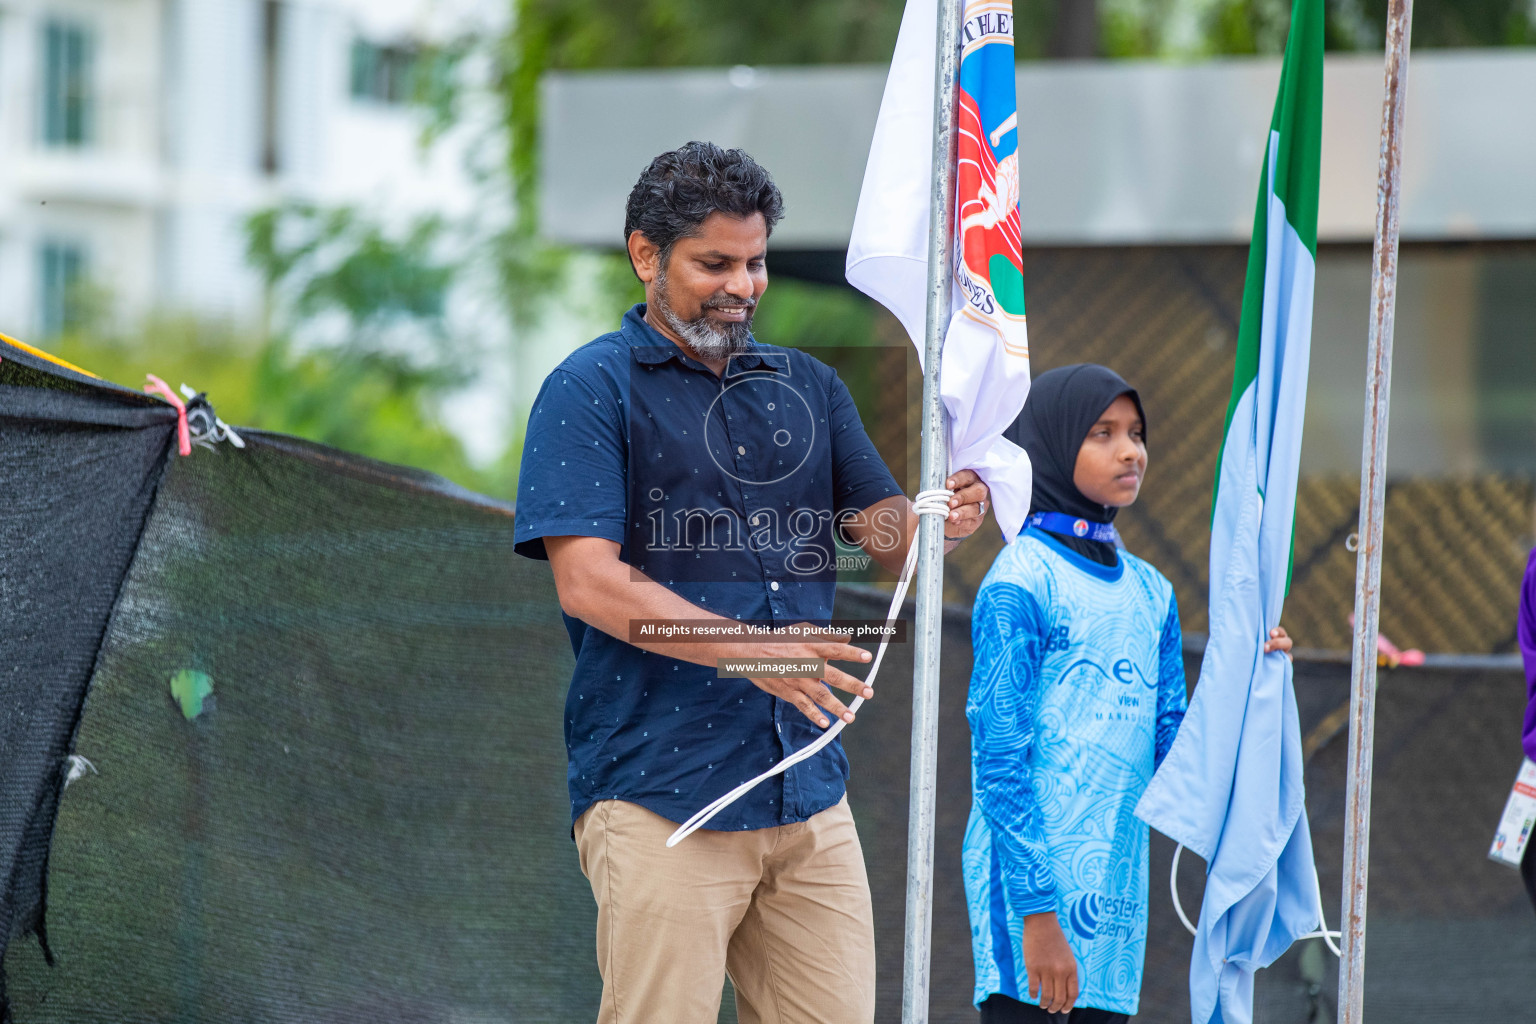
[541,49,1536,651]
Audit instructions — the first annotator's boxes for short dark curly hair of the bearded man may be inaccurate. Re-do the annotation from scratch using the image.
[624,143,783,263]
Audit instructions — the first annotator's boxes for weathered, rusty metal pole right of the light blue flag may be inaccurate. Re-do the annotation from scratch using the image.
[1338,0,1413,1024]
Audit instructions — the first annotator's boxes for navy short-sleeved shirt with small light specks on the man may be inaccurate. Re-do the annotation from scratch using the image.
[516,304,902,831]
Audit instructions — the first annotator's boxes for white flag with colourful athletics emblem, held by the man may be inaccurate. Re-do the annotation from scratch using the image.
[846,0,1029,542]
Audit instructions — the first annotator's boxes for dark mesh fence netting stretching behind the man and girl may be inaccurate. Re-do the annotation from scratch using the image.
[0,346,1536,1024]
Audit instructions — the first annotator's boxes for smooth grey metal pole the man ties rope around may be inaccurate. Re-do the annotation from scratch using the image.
[902,0,960,1024]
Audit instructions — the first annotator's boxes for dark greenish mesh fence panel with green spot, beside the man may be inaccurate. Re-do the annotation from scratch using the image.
[8,436,593,1022]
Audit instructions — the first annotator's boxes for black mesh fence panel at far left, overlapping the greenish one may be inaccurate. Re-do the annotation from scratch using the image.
[0,350,174,1009]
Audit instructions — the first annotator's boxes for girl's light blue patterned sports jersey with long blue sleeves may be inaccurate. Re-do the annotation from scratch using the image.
[963,530,1186,1013]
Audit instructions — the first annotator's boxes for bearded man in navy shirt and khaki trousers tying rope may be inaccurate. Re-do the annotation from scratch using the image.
[516,143,986,1024]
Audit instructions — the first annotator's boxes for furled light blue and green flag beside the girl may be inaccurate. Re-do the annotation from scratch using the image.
[1137,0,1322,1024]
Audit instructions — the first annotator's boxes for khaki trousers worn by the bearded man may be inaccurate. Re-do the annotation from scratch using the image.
[574,797,874,1024]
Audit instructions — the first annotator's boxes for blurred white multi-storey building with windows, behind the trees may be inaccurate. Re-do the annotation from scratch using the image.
[0,0,508,338]
